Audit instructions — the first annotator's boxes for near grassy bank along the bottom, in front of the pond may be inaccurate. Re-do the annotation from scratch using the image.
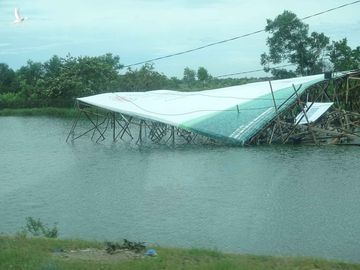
[0,235,360,270]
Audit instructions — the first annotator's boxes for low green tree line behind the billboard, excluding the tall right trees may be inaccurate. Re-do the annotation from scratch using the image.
[0,54,258,109]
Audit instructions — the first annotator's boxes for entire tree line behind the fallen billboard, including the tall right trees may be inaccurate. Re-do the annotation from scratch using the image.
[0,11,360,109]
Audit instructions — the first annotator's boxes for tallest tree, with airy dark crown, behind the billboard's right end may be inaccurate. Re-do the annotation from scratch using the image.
[261,11,329,75]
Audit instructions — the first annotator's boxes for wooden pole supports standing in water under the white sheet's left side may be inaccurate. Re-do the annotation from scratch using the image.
[66,101,216,147]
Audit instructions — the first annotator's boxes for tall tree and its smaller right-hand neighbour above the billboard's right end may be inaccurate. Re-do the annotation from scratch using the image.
[261,10,360,78]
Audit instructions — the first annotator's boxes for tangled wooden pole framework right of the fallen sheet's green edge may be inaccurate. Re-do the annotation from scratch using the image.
[248,71,360,145]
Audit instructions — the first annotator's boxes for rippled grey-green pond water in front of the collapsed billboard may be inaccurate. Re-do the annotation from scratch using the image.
[0,117,360,263]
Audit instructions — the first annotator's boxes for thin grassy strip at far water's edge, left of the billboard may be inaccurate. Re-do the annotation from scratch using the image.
[0,107,76,117]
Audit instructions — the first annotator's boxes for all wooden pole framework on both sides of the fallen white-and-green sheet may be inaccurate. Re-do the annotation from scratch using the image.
[66,71,360,147]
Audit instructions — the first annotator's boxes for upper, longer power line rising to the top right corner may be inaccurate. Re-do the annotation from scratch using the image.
[124,0,360,69]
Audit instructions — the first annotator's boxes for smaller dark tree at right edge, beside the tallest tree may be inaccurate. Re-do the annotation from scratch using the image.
[329,38,360,71]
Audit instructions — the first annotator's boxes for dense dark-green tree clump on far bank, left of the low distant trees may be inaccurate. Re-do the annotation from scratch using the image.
[0,54,122,108]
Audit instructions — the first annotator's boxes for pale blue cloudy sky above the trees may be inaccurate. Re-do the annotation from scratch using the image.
[0,0,360,78]
